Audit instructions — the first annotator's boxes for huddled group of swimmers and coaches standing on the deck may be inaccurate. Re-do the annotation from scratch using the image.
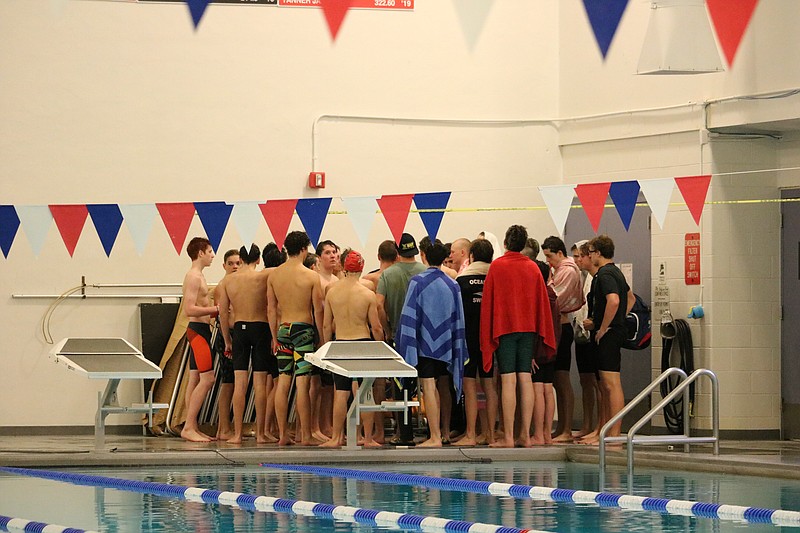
[175,225,632,447]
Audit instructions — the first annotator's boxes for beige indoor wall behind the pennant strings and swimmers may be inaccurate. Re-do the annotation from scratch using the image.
[0,0,800,429]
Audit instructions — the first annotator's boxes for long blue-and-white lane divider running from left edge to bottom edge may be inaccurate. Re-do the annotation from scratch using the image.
[0,467,547,533]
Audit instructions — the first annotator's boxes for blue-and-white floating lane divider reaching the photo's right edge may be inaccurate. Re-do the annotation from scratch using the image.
[261,463,800,527]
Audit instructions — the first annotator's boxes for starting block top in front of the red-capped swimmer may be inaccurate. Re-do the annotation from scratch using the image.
[305,341,417,378]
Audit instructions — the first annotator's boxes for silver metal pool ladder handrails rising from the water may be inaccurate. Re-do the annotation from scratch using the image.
[599,367,719,490]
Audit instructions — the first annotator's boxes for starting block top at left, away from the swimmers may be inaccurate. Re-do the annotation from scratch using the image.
[50,337,161,379]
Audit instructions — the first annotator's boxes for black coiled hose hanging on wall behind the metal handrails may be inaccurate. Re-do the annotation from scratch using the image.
[661,318,694,435]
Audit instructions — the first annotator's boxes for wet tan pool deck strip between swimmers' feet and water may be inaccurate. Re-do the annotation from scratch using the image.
[0,435,800,480]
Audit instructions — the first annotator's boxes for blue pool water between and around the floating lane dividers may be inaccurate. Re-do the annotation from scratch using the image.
[0,462,800,533]
